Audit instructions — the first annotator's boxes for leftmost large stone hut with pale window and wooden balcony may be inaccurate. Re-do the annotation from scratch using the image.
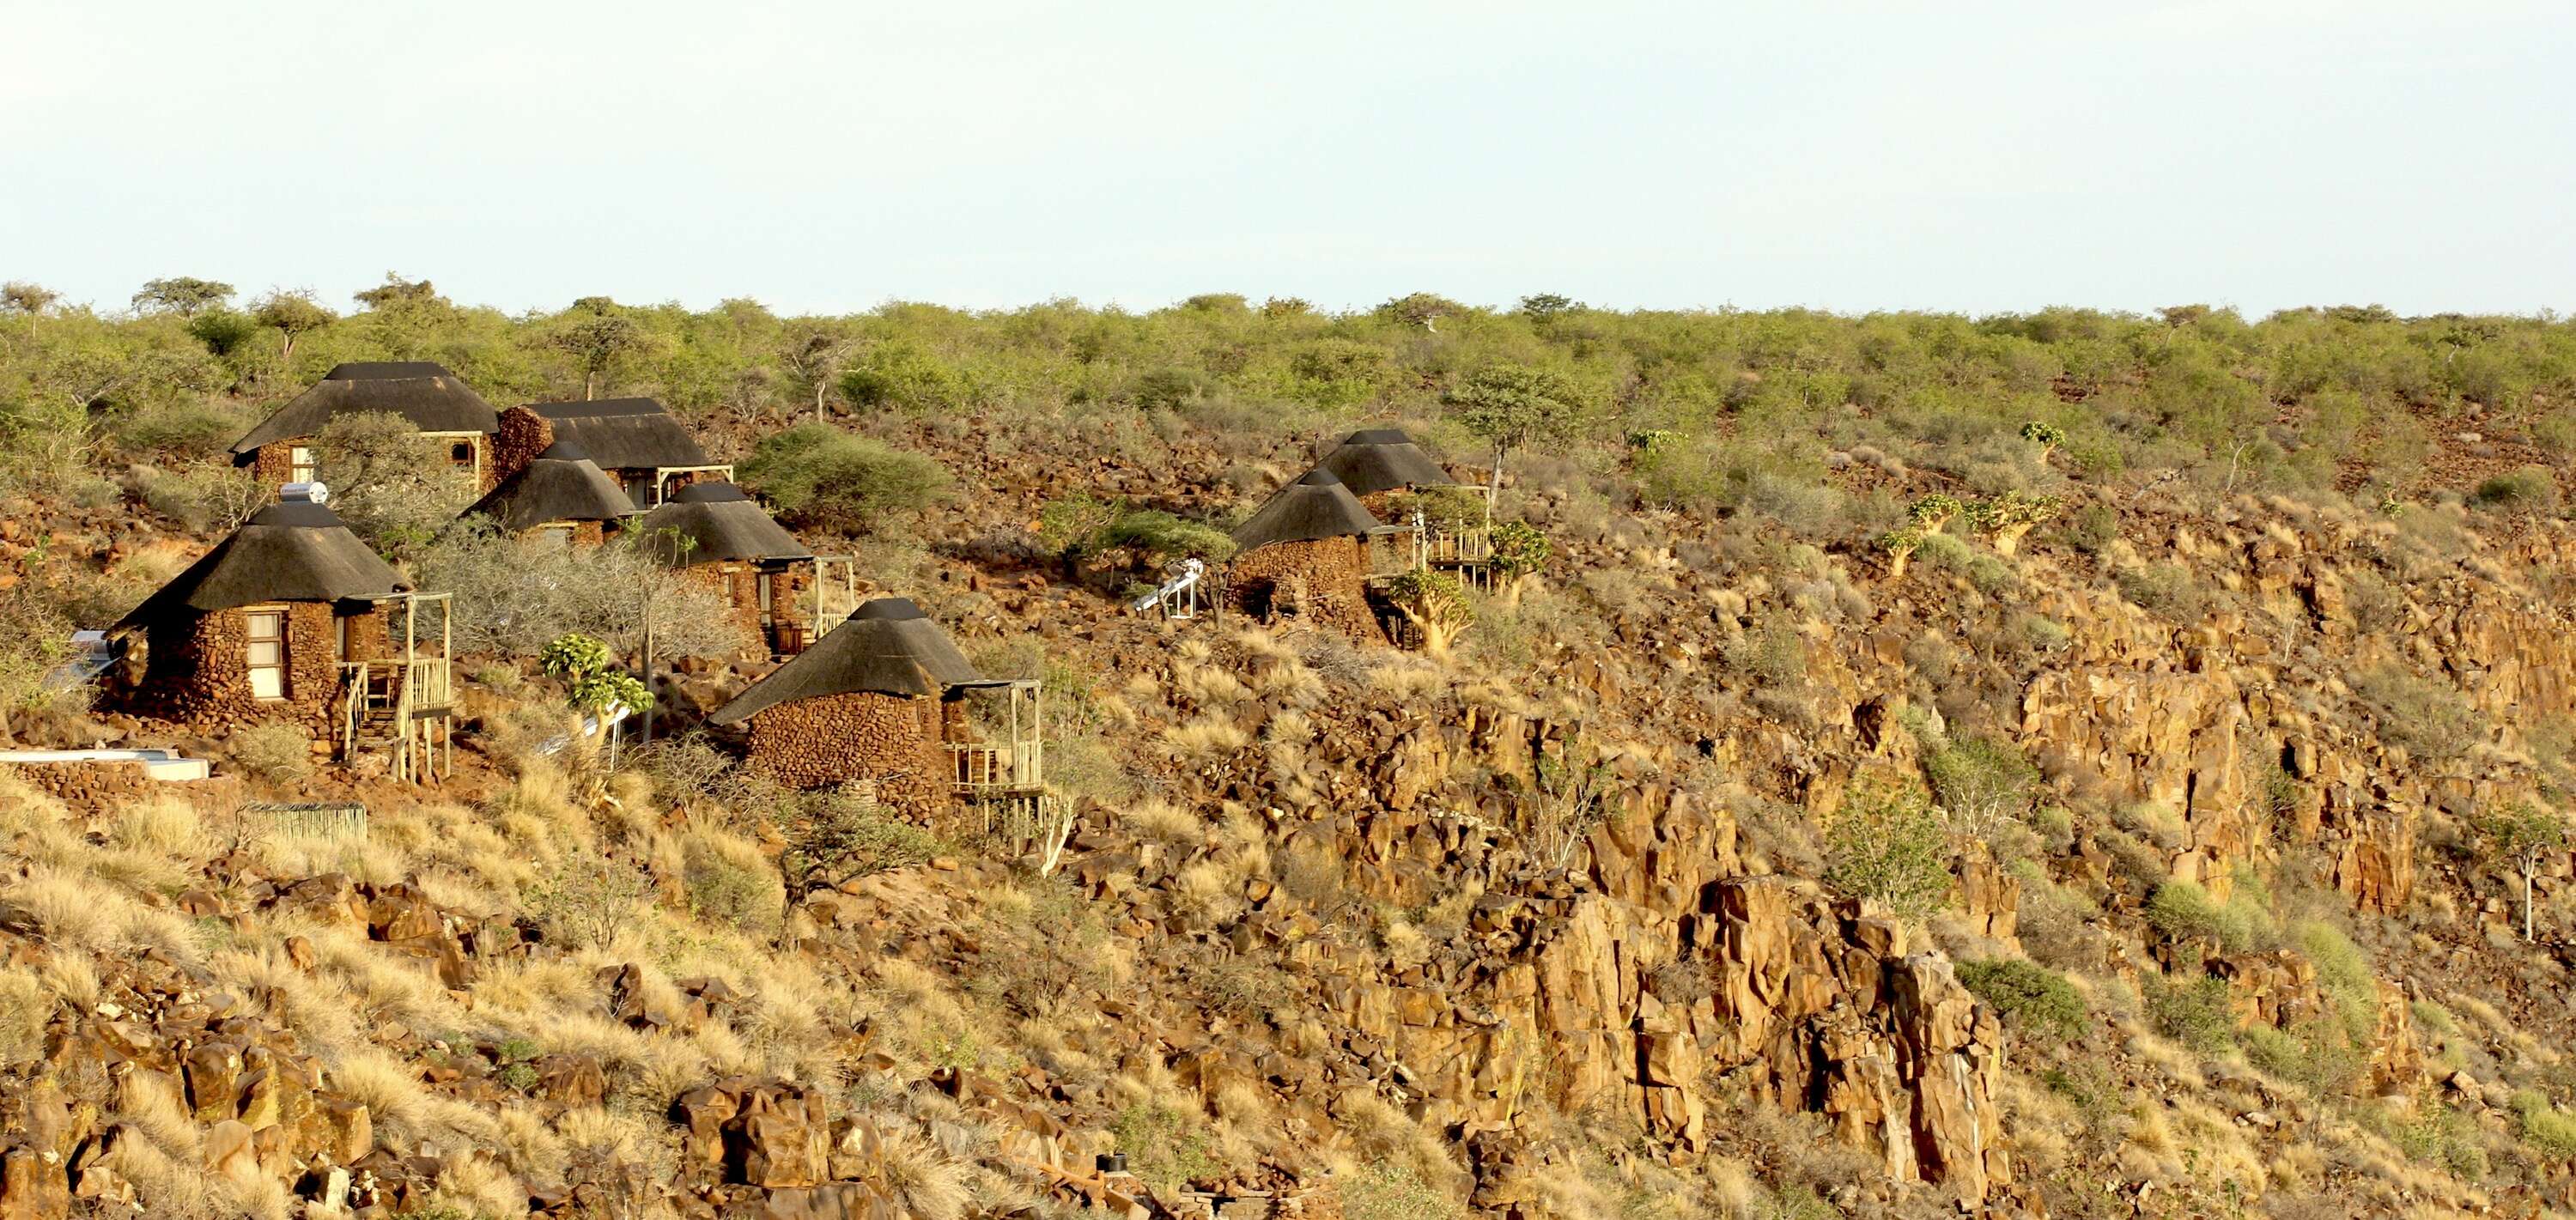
[108,502,407,738]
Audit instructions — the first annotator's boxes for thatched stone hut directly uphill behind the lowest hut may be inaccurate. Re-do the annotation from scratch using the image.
[626,482,817,656]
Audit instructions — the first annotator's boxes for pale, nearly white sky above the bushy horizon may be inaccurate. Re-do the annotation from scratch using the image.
[0,0,2576,314]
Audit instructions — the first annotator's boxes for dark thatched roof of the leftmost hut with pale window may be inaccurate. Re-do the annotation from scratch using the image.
[116,502,407,628]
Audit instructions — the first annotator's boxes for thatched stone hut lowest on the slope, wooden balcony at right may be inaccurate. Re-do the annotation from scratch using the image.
[708,598,1043,813]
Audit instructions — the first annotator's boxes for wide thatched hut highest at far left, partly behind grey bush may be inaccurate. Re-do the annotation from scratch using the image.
[232,361,500,489]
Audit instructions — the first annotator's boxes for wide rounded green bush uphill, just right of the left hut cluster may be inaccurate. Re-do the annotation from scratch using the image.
[742,422,953,533]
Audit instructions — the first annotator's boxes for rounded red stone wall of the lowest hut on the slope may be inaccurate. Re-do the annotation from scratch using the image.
[750,692,951,813]
